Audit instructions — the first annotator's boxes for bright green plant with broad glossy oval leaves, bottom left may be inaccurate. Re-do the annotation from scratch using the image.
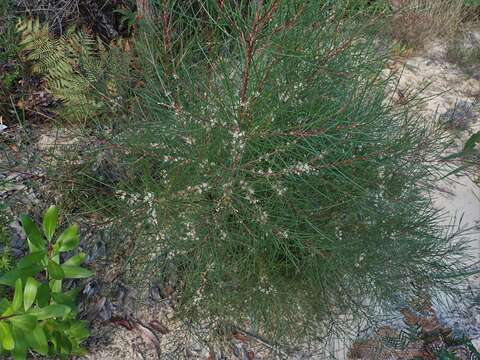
[0,206,92,360]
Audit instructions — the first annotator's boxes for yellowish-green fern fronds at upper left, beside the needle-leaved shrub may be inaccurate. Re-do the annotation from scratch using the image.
[17,19,112,119]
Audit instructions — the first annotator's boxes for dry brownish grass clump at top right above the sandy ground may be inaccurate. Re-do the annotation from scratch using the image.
[391,0,464,49]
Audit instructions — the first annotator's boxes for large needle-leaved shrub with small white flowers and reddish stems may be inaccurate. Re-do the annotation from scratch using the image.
[56,0,472,341]
